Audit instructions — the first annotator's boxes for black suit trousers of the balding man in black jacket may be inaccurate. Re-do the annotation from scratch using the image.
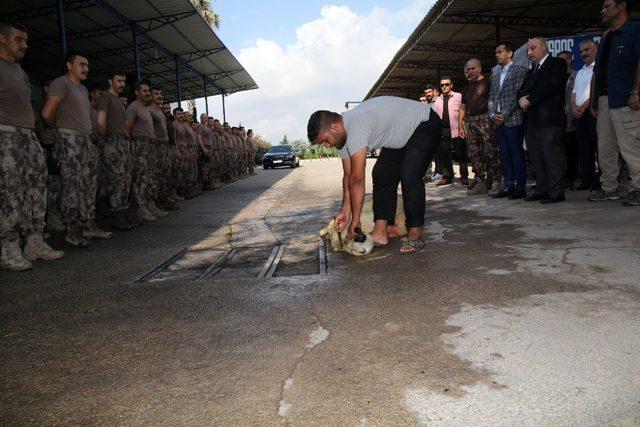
[524,122,566,197]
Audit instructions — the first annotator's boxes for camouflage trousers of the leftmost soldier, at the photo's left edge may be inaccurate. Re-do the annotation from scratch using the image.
[0,129,47,240]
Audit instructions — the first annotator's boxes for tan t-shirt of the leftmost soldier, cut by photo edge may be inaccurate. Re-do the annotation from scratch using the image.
[0,58,35,128]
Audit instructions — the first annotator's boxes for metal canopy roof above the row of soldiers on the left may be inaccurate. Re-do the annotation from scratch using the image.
[0,0,258,101]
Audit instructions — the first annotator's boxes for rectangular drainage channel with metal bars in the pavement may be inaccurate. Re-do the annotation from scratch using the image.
[135,241,328,283]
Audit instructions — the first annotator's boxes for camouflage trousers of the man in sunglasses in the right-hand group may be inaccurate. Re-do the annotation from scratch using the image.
[466,116,502,182]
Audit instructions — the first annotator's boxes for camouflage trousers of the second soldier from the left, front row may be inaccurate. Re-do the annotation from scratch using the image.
[56,130,98,225]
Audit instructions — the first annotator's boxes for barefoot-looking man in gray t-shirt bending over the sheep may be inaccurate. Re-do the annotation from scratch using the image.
[307,96,442,253]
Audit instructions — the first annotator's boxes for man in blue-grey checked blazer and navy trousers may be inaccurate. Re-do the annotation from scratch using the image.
[489,42,527,200]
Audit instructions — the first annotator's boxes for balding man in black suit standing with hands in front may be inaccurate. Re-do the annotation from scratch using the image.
[516,37,567,203]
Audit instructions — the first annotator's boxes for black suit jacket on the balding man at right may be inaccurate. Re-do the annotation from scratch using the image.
[516,55,567,126]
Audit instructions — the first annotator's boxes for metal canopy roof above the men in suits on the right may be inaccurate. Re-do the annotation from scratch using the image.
[365,0,602,99]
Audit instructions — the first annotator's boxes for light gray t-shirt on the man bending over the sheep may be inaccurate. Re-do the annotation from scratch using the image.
[338,96,431,159]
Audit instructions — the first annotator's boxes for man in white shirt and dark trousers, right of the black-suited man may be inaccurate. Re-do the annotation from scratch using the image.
[571,40,598,191]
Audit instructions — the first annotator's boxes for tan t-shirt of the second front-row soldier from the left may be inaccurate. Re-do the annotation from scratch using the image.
[49,76,91,135]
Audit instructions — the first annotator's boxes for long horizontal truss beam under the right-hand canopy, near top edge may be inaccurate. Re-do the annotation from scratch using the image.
[438,13,600,29]
